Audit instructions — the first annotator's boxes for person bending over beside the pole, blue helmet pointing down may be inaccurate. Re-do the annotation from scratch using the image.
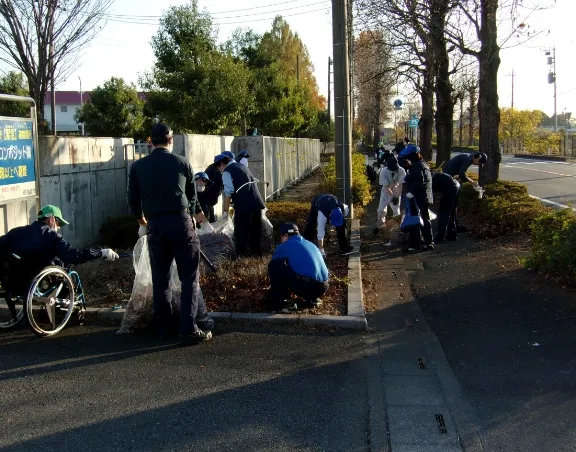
[304,194,354,257]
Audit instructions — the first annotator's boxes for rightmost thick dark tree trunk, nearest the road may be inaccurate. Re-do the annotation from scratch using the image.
[478,0,502,185]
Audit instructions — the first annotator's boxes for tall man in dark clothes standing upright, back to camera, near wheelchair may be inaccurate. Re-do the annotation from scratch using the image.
[126,124,214,345]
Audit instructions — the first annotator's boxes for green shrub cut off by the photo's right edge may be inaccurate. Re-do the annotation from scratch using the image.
[524,209,576,280]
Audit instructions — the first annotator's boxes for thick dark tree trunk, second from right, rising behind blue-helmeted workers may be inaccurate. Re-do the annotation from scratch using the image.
[430,0,454,165]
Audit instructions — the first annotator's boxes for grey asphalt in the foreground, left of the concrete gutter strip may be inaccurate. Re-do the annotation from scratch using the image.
[0,326,368,452]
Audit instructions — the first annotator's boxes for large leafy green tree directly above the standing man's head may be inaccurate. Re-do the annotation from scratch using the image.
[141,0,250,134]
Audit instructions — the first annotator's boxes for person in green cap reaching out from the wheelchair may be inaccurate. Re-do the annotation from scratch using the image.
[0,205,118,295]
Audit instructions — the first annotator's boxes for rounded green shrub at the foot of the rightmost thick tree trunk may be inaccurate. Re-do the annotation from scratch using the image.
[458,181,548,235]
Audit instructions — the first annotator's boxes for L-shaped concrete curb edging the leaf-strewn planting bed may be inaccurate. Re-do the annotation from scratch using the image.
[86,219,368,331]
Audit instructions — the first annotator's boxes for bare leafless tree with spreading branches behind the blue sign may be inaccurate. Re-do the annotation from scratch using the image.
[0,0,112,129]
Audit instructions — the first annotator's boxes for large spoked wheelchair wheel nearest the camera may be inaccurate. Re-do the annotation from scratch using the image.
[24,267,75,337]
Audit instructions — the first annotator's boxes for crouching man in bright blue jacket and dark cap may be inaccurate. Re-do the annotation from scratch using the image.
[268,223,329,313]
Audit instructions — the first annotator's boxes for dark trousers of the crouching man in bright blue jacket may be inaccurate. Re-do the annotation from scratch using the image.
[268,259,329,310]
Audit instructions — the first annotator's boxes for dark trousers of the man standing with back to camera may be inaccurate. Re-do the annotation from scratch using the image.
[147,212,214,334]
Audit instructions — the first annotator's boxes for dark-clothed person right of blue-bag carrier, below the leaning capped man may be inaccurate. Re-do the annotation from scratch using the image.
[432,173,460,243]
